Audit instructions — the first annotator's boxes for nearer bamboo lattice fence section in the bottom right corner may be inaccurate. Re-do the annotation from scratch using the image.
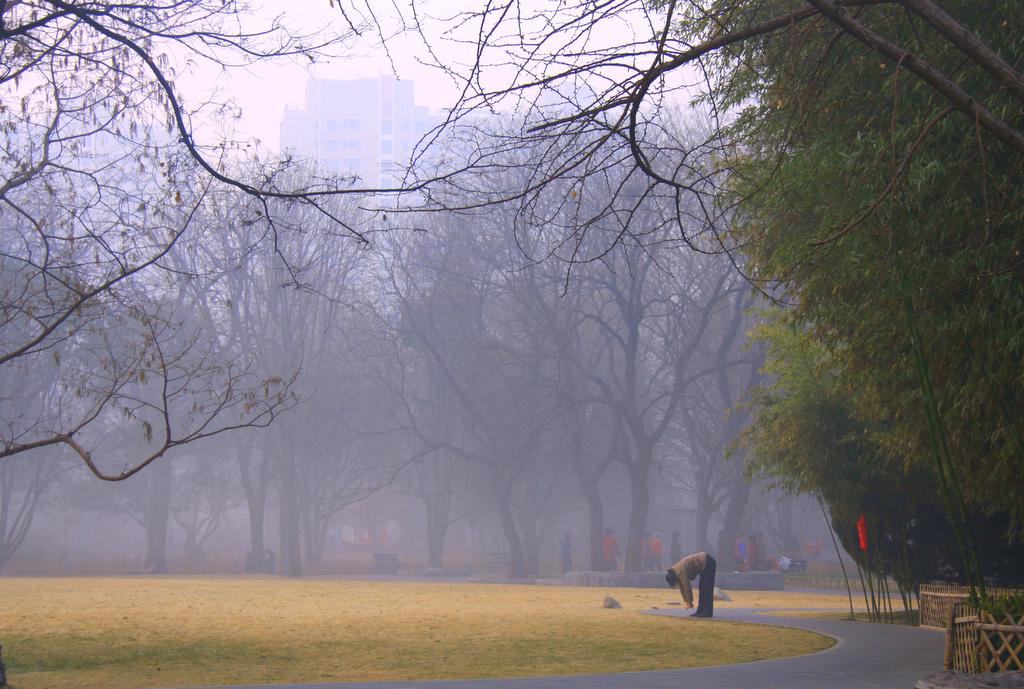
[945,603,1024,673]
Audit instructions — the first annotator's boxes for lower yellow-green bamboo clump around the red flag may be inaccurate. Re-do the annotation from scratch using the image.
[743,313,1024,592]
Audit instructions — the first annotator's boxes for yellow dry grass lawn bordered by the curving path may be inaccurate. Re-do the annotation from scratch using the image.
[0,577,833,689]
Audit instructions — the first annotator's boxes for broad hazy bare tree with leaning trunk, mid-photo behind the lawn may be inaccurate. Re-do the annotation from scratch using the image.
[378,216,560,576]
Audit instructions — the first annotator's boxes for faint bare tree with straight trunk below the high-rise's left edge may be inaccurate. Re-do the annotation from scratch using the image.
[218,177,369,575]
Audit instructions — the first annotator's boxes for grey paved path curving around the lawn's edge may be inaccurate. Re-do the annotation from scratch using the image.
[182,608,943,689]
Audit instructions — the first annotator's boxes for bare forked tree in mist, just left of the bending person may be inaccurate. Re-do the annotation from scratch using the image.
[581,233,735,571]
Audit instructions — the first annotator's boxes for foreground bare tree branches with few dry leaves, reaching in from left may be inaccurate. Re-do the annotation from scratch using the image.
[0,0,401,480]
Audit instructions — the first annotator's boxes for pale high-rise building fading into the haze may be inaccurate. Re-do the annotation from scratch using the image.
[281,77,439,187]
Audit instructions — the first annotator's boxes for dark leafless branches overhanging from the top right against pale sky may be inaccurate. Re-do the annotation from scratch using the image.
[395,0,1024,261]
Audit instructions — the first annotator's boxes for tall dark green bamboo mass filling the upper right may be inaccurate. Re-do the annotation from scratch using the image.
[704,0,1024,548]
